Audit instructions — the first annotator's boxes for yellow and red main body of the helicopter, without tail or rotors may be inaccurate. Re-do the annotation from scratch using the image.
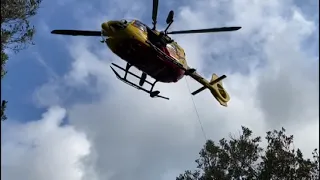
[102,20,187,83]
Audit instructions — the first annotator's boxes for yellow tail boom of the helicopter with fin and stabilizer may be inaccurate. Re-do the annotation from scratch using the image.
[189,72,230,107]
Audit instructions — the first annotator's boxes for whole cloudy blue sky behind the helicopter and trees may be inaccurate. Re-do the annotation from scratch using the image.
[1,0,319,180]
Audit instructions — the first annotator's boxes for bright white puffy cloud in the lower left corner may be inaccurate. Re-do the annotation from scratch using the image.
[1,107,93,180]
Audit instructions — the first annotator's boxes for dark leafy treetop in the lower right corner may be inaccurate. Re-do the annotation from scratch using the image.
[176,127,319,180]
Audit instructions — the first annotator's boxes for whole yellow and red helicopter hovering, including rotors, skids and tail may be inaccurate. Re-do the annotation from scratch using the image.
[51,0,241,107]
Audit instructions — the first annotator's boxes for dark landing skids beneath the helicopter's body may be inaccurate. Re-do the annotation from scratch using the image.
[110,63,169,100]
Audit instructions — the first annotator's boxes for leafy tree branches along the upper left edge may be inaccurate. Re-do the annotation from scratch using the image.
[1,0,41,120]
